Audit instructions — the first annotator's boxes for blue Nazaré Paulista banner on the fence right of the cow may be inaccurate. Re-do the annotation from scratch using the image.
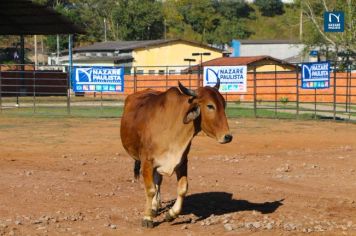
[302,62,330,89]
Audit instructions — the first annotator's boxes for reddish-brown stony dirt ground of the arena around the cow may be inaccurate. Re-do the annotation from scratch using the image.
[0,116,356,235]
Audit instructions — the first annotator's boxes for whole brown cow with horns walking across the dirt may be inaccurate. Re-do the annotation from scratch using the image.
[120,80,232,228]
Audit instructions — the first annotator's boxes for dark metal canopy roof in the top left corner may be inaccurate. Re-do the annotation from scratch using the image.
[0,0,85,35]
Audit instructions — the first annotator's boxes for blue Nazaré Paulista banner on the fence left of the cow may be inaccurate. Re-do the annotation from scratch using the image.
[72,66,124,92]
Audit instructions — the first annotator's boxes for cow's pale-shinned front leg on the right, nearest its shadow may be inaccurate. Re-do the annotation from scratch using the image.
[166,157,188,221]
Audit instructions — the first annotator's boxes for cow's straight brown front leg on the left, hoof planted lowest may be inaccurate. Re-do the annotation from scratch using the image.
[142,160,156,228]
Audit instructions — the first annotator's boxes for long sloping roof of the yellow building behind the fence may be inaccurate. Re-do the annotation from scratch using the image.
[74,39,222,52]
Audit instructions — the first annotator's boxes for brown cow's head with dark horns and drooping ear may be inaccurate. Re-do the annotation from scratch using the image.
[178,79,232,143]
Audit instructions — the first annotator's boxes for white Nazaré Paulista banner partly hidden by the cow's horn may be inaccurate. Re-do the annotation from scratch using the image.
[203,66,247,92]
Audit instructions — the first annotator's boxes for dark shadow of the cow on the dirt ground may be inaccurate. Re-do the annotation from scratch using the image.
[162,192,284,225]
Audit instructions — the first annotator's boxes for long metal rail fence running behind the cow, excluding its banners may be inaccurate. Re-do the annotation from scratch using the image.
[0,62,356,121]
